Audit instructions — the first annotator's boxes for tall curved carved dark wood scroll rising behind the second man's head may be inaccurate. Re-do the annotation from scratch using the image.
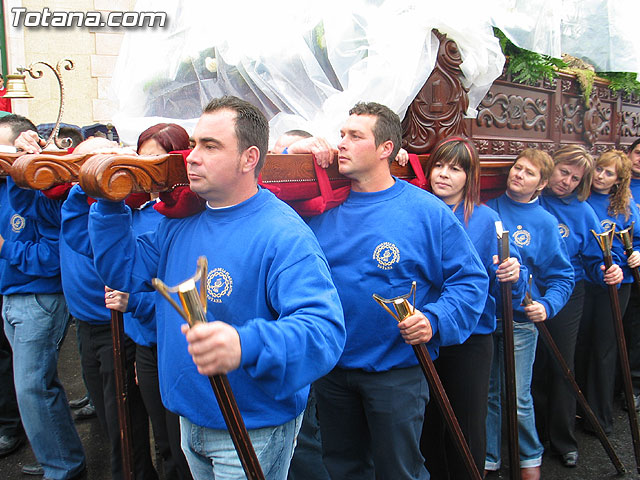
[402,30,469,153]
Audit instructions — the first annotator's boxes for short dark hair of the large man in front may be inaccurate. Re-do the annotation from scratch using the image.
[202,96,269,177]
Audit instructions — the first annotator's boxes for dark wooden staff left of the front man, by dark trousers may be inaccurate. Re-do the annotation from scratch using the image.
[111,310,135,480]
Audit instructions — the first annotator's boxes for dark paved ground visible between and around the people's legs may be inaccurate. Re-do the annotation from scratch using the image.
[0,320,640,480]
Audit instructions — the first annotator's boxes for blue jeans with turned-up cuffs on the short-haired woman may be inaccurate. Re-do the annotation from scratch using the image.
[485,322,544,470]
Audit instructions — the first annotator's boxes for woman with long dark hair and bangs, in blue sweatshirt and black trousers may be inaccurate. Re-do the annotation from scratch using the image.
[421,137,528,479]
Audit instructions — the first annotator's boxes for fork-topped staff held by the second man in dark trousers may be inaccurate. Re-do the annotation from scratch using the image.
[373,282,482,480]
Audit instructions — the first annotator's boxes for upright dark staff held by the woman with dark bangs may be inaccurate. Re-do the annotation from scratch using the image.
[496,221,520,480]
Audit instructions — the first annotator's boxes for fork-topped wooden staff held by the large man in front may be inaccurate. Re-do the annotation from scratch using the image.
[152,257,264,480]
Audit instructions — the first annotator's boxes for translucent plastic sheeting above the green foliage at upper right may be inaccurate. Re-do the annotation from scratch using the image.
[487,0,640,73]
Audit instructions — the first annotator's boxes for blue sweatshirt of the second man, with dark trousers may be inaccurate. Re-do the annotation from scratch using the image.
[309,179,488,372]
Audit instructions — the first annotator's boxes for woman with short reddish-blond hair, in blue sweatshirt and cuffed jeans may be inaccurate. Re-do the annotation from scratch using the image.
[485,148,574,480]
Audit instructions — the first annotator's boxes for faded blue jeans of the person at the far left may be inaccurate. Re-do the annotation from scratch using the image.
[2,294,85,480]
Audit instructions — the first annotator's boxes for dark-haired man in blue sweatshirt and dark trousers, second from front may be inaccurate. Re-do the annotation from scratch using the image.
[309,103,488,479]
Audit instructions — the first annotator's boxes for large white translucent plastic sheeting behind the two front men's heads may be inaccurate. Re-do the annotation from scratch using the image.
[112,0,504,143]
